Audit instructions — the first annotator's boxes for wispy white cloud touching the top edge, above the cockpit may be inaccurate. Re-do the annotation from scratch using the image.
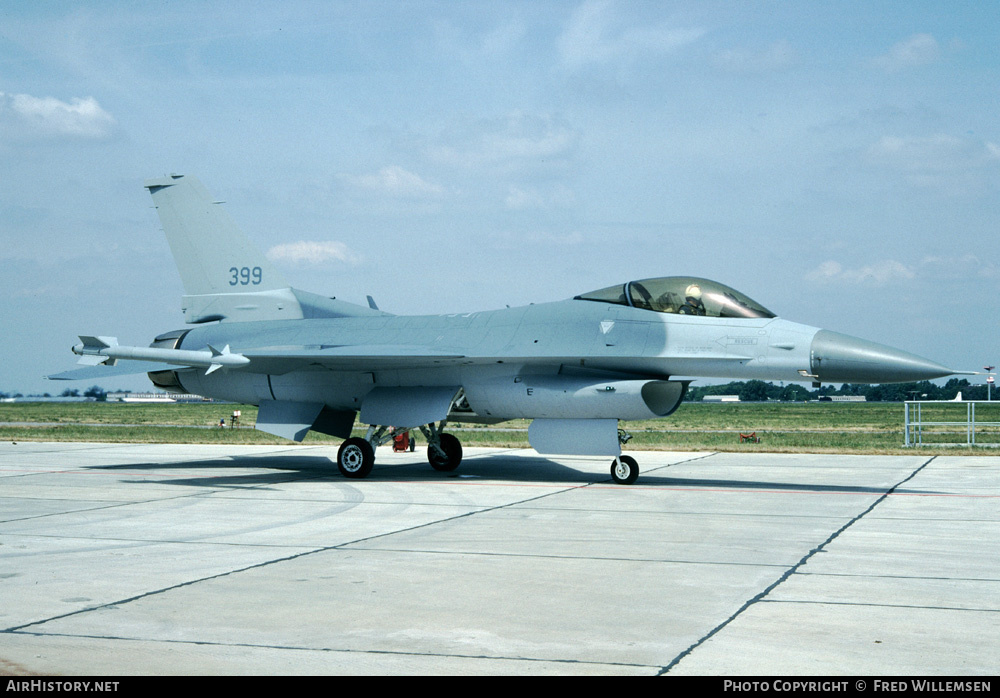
[557,0,705,68]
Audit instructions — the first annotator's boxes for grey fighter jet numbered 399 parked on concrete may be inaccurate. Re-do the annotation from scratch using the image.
[50,174,955,484]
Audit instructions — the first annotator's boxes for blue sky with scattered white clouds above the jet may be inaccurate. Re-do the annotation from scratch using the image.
[0,0,1000,394]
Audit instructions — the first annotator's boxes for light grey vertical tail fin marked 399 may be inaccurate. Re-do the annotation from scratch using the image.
[145,174,382,323]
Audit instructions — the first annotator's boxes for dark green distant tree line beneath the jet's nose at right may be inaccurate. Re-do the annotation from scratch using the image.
[684,378,988,402]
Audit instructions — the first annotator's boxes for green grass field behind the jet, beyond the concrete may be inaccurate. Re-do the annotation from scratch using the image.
[0,401,1000,455]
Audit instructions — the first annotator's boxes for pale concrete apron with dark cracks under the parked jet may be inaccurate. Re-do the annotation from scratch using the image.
[0,442,1000,676]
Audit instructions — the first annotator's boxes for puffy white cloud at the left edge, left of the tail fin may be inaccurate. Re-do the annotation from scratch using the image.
[0,92,117,139]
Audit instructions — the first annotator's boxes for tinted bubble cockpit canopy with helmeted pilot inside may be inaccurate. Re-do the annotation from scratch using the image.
[576,276,775,318]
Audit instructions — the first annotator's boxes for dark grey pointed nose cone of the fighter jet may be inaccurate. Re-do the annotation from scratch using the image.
[810,330,954,383]
